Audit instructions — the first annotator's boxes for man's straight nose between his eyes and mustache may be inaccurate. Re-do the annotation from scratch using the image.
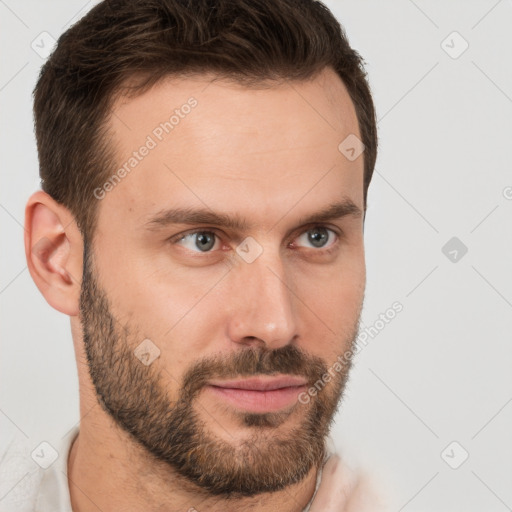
[228,251,297,349]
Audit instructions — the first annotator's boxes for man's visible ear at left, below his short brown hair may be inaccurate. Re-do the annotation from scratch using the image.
[25,190,83,316]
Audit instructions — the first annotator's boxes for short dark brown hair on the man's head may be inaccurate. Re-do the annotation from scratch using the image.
[34,0,377,236]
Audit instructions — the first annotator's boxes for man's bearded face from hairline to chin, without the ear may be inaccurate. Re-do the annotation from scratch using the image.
[80,67,365,496]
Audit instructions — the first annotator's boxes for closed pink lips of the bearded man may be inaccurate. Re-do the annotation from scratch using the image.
[206,375,307,413]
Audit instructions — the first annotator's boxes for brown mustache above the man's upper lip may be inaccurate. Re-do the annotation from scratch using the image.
[181,345,327,400]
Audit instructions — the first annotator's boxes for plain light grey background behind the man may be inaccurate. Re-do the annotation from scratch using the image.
[0,0,512,512]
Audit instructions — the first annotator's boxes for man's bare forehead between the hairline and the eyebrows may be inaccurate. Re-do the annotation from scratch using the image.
[100,70,363,234]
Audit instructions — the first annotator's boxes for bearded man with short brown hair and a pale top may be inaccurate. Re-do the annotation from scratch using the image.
[0,0,384,512]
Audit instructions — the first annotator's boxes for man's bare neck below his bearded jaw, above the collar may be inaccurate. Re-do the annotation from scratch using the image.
[64,416,318,512]
